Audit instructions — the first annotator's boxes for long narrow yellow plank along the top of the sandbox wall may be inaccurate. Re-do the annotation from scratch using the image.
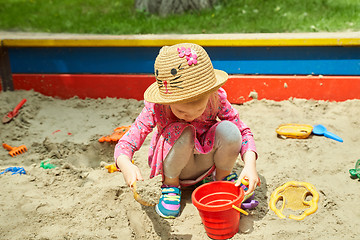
[2,38,360,47]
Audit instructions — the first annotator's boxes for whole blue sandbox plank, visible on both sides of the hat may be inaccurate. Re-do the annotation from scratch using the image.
[9,46,360,75]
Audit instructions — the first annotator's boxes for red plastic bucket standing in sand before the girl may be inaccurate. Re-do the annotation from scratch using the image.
[191,181,244,239]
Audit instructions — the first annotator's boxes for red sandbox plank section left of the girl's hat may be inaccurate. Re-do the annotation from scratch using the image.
[13,74,155,100]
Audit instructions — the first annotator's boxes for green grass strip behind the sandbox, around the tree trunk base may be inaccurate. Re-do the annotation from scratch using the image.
[0,0,360,34]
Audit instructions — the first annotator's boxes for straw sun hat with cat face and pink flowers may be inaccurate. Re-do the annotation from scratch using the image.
[144,43,228,104]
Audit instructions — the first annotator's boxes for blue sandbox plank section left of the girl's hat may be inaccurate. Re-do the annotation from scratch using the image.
[10,48,157,73]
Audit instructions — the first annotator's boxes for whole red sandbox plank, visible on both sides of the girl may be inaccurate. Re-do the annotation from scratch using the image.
[13,74,360,103]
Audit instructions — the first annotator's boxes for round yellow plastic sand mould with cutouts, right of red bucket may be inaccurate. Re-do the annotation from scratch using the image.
[269,181,319,221]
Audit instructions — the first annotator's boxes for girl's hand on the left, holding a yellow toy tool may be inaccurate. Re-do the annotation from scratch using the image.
[116,155,144,187]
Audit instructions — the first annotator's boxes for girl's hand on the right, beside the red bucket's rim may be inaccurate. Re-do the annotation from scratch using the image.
[235,151,260,195]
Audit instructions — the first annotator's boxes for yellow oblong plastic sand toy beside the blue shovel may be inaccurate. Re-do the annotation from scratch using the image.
[275,123,313,139]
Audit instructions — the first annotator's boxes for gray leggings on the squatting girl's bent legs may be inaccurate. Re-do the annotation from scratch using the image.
[163,121,242,180]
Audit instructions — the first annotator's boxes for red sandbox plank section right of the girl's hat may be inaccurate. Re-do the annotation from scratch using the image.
[225,76,360,103]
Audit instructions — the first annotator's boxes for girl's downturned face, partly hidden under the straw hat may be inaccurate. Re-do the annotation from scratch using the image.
[170,95,209,122]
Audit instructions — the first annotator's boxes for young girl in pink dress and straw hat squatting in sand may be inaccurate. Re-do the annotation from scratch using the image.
[114,43,259,218]
